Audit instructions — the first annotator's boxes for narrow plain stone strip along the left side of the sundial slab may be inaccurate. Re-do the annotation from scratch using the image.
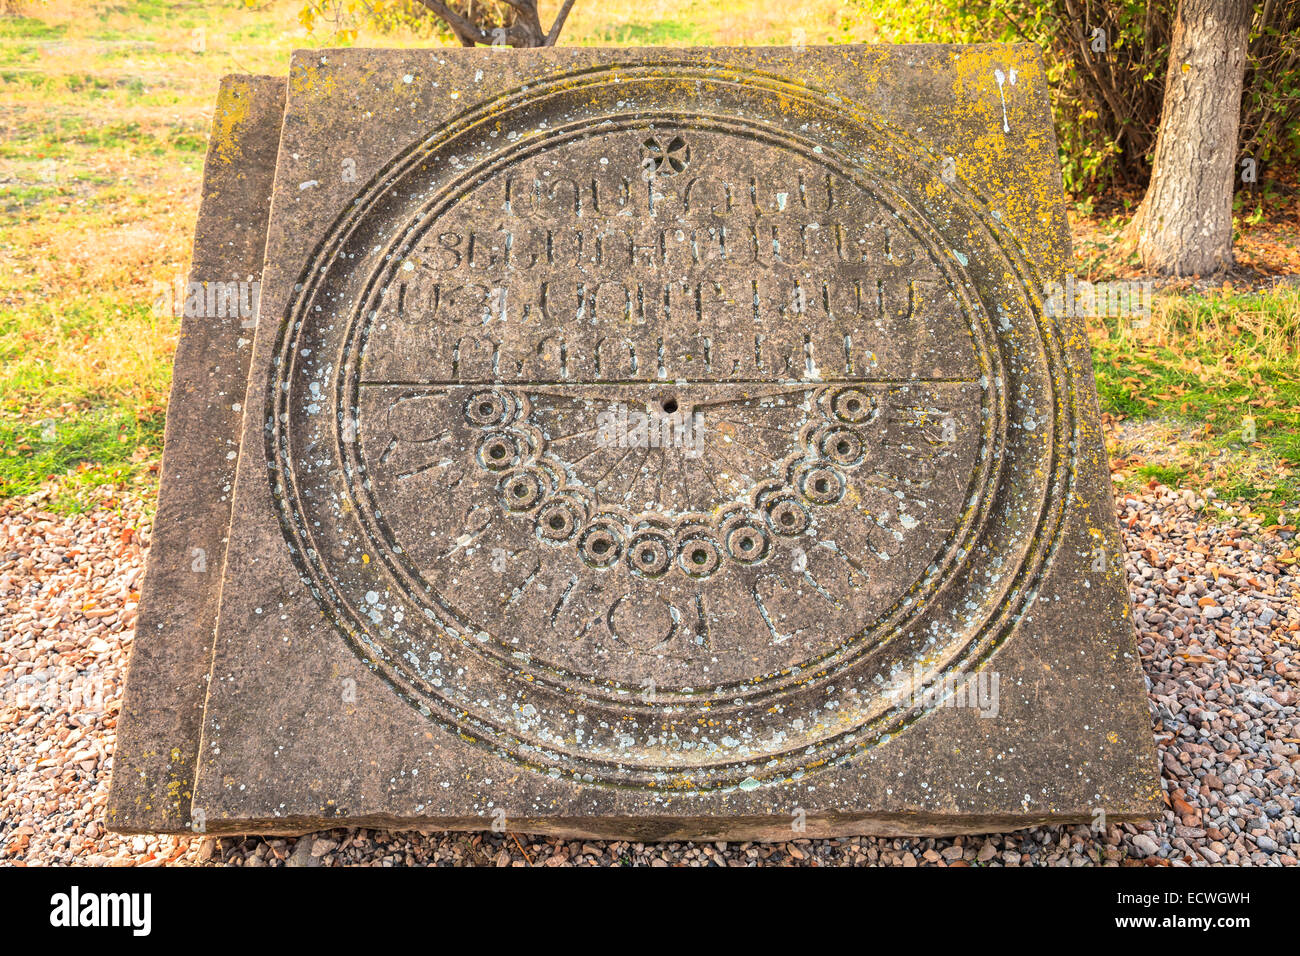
[105,77,285,832]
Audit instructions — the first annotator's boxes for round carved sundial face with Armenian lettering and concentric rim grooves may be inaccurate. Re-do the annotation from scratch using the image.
[267,63,1069,790]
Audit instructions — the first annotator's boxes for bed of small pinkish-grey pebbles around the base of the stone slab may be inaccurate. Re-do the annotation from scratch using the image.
[0,486,1300,866]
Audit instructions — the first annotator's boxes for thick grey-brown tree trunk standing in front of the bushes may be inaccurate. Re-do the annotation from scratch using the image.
[1127,0,1251,276]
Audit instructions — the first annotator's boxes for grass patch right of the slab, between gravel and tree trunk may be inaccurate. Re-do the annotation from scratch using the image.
[1092,286,1300,524]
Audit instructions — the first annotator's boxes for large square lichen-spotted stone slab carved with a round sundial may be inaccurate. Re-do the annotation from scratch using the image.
[185,46,1160,839]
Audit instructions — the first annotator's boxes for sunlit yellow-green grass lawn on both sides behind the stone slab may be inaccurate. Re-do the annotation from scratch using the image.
[0,0,1300,518]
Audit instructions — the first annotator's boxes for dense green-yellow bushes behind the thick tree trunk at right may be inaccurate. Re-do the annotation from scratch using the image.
[858,0,1300,195]
